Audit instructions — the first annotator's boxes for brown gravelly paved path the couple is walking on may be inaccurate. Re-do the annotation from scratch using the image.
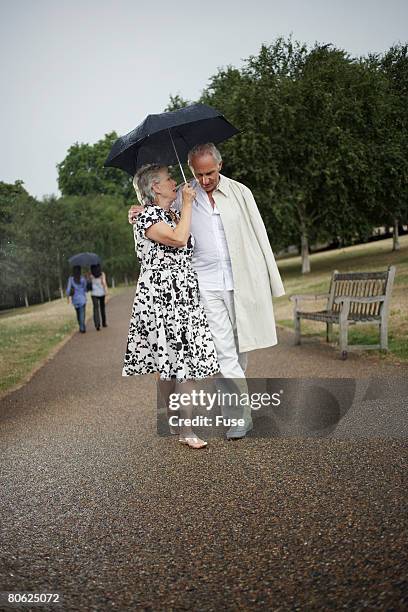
[0,290,408,611]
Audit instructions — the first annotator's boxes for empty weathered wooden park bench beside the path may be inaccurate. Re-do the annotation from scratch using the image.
[290,266,395,359]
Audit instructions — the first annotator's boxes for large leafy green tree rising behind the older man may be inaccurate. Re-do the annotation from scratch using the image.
[202,38,390,273]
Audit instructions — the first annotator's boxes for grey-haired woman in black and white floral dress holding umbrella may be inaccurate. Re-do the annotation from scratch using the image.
[122,164,219,448]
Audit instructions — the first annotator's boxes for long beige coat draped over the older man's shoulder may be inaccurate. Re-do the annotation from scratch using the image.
[213,175,285,353]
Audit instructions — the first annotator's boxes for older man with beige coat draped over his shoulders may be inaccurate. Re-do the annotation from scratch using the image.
[129,143,285,438]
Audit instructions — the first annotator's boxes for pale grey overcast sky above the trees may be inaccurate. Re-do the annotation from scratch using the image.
[0,0,408,198]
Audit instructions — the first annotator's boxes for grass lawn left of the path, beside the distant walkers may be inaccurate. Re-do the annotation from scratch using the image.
[0,286,126,394]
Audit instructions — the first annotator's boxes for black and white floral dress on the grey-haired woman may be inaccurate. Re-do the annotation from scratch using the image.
[122,205,219,382]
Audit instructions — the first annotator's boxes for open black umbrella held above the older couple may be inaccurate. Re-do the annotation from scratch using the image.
[104,104,239,180]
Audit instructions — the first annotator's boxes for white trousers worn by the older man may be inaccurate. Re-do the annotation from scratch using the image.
[200,289,250,419]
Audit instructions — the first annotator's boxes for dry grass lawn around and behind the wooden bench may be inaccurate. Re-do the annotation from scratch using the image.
[274,236,408,362]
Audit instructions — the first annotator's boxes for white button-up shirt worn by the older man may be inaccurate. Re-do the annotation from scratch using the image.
[173,177,234,291]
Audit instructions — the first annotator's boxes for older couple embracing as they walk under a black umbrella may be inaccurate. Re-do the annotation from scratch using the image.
[122,143,285,448]
